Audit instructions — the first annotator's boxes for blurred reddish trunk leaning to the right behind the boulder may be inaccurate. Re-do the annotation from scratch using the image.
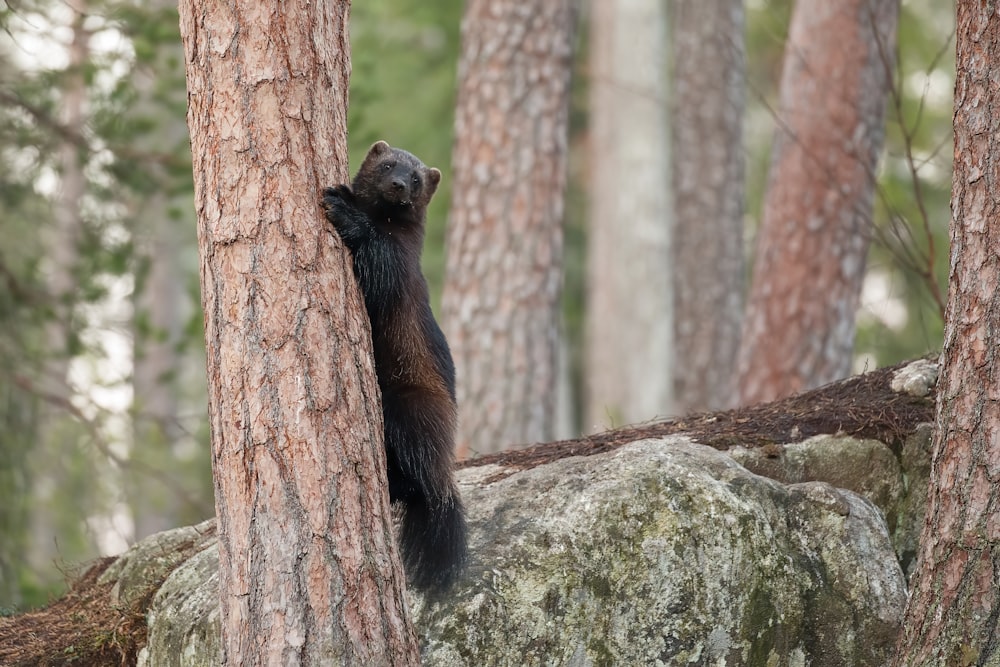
[738,0,899,404]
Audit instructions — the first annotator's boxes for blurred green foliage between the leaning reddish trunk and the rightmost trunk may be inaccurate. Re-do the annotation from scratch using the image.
[856,0,955,366]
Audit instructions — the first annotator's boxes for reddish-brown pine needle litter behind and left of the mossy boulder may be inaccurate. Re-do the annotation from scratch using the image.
[0,366,934,666]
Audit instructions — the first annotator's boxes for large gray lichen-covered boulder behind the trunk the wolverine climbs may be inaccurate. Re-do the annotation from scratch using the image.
[125,436,906,667]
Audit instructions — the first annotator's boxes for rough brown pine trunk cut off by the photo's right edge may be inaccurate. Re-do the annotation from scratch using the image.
[894,6,1000,667]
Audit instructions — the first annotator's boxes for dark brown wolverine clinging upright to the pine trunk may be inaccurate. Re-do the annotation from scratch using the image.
[323,141,466,592]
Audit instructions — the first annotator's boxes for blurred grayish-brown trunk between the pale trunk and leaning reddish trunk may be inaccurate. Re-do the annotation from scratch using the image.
[670,0,746,414]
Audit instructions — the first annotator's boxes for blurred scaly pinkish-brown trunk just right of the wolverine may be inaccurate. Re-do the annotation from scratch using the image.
[442,0,576,457]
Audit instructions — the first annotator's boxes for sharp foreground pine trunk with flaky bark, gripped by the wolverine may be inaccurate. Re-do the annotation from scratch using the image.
[180,0,419,665]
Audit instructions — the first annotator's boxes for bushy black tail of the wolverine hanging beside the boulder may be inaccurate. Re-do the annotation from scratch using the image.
[399,492,467,594]
